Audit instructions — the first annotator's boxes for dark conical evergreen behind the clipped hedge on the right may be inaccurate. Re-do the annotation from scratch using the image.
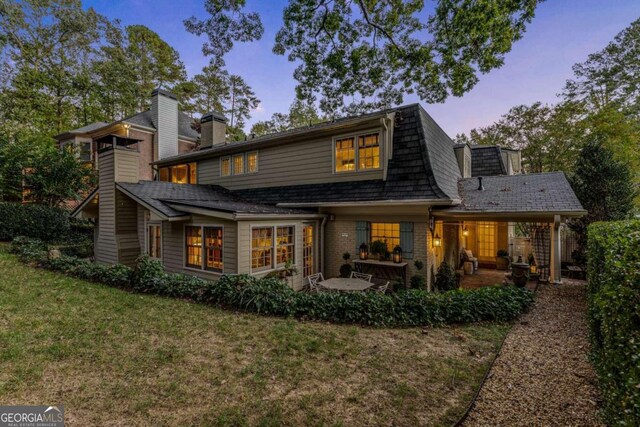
[570,139,637,259]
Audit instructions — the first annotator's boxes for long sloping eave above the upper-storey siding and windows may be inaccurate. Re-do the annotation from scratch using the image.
[151,109,395,166]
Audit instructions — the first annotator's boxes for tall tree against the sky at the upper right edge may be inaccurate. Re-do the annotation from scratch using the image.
[562,19,640,117]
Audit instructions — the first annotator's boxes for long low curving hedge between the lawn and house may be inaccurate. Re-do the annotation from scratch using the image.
[12,238,533,326]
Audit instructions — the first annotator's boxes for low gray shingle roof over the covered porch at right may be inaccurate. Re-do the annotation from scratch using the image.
[445,172,584,213]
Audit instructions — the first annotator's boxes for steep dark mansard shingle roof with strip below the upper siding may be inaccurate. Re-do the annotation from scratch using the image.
[236,105,460,204]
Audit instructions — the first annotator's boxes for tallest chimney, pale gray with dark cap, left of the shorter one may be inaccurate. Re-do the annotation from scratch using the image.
[151,89,178,160]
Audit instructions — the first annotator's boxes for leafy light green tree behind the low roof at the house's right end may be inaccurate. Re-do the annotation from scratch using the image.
[456,102,586,173]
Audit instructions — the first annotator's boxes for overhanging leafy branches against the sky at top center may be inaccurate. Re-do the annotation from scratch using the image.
[185,0,540,115]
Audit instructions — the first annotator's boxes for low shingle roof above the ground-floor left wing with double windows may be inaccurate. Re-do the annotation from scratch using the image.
[118,181,309,217]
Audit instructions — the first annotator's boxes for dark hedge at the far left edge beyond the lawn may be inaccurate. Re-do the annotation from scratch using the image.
[0,202,93,242]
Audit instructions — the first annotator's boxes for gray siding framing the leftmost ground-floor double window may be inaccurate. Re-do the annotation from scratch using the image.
[162,215,237,280]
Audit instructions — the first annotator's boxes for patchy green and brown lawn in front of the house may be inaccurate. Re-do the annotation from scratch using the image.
[0,246,509,426]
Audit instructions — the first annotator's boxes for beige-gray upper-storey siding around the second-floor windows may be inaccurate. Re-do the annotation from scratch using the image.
[198,128,385,190]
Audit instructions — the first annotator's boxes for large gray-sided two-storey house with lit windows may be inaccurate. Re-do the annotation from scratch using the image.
[73,91,585,289]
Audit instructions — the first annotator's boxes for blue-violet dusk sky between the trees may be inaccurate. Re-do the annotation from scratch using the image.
[83,0,640,137]
